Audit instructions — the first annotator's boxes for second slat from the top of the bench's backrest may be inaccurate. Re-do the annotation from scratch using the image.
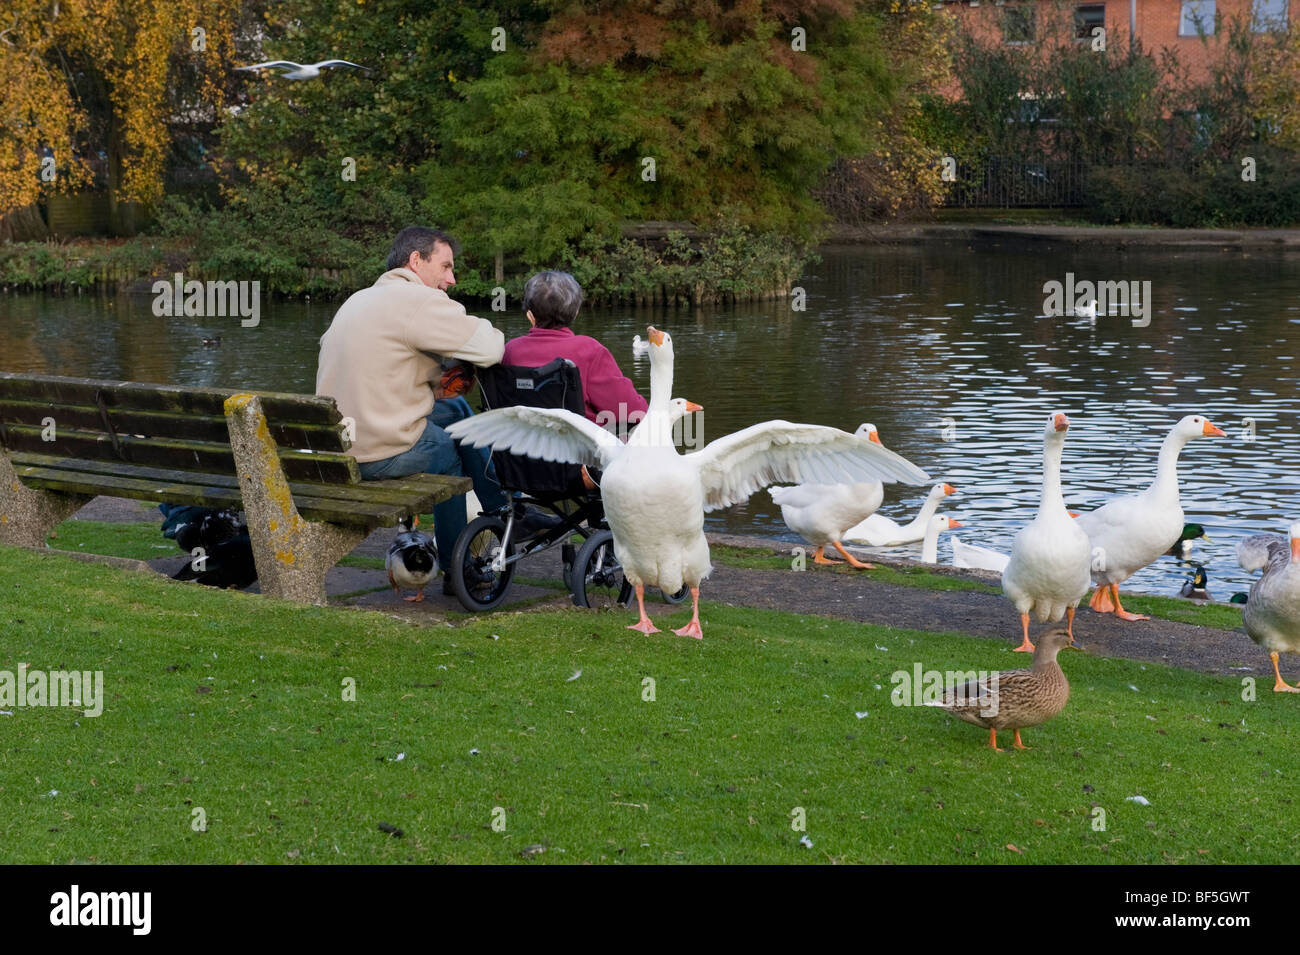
[0,398,351,453]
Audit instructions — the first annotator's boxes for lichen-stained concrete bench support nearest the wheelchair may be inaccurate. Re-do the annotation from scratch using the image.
[225,395,365,604]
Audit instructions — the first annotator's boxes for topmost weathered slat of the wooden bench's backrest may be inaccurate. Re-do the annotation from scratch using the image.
[0,372,343,425]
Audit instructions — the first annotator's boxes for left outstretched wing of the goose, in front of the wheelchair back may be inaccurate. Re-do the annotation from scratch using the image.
[447,405,623,468]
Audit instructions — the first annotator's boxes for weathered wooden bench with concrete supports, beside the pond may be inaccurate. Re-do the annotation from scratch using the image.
[0,372,471,604]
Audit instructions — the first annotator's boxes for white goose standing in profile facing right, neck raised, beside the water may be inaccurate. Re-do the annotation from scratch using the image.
[1076,414,1223,620]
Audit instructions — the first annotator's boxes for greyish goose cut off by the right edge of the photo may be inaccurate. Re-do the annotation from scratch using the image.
[1236,522,1300,693]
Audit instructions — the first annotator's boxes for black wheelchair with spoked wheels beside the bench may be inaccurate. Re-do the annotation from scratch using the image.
[447,359,689,612]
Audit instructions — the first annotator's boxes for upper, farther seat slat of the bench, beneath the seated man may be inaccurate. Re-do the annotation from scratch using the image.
[10,453,471,511]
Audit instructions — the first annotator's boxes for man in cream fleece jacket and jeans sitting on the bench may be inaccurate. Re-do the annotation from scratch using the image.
[316,226,506,592]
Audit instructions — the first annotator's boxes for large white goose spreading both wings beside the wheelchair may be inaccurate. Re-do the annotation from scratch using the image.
[447,326,930,639]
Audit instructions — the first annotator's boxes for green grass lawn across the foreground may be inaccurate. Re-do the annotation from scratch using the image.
[0,545,1300,863]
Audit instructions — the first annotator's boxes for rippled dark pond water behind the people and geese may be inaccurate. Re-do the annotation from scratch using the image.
[0,243,1300,599]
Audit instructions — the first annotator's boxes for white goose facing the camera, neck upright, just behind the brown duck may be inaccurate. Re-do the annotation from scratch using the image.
[1002,412,1091,654]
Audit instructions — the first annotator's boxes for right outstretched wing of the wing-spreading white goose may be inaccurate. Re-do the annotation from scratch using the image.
[684,421,930,511]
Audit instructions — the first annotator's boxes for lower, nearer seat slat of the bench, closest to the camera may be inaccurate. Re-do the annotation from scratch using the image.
[14,464,425,528]
